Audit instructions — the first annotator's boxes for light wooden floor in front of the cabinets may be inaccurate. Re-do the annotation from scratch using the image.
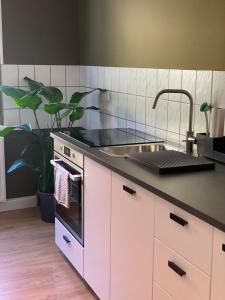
[0,208,96,300]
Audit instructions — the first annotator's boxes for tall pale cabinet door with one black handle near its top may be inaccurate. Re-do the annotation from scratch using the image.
[110,173,154,300]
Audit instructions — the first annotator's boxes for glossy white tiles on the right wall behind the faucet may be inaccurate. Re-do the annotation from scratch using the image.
[80,66,225,144]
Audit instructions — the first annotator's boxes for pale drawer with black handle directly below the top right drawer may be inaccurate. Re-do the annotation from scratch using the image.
[154,239,210,300]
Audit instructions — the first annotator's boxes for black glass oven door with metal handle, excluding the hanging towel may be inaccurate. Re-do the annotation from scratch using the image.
[53,153,83,246]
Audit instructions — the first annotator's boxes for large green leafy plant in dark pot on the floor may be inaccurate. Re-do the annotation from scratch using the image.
[0,77,105,222]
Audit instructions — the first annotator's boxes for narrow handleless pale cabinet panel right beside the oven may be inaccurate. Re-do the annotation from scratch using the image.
[84,157,111,300]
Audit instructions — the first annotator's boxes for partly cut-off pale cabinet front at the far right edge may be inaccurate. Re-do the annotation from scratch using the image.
[211,229,225,300]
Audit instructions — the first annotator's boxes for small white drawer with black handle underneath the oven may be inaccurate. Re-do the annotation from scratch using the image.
[55,219,84,276]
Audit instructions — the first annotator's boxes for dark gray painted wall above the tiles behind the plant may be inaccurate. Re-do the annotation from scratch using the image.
[2,0,79,65]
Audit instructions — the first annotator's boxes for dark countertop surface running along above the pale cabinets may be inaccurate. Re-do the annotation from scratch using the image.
[51,133,225,232]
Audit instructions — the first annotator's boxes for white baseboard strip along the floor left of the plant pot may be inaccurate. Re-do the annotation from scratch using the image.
[0,195,37,212]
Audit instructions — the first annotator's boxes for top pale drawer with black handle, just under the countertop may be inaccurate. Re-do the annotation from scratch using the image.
[155,199,213,275]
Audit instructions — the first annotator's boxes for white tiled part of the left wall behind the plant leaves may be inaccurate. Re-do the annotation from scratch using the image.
[1,65,79,128]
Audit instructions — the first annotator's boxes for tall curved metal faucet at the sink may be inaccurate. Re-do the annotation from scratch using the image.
[152,89,195,154]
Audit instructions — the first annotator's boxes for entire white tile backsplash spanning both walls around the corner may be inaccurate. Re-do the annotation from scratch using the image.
[1,65,225,145]
